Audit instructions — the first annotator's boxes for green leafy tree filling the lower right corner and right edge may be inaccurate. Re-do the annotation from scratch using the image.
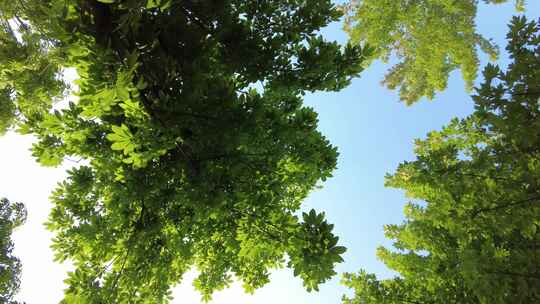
[344,17,540,303]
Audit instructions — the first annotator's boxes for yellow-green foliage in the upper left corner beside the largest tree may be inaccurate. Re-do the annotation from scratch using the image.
[0,1,67,135]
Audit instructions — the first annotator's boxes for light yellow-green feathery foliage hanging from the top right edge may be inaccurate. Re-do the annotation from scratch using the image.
[344,0,525,105]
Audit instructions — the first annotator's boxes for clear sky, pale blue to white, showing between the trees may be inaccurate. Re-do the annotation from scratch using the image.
[4,0,540,304]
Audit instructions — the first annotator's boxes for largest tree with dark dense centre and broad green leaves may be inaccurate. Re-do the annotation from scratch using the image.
[0,0,369,303]
